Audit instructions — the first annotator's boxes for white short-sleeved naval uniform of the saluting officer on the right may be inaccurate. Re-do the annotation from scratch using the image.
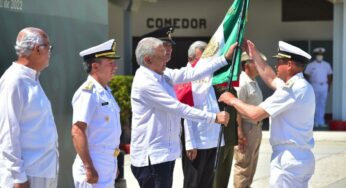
[259,73,315,188]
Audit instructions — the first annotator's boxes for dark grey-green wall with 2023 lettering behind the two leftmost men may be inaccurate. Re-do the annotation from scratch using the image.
[0,0,108,188]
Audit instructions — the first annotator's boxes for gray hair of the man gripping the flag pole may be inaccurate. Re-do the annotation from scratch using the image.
[136,37,163,66]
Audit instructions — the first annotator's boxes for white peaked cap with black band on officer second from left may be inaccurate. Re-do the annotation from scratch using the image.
[79,39,120,61]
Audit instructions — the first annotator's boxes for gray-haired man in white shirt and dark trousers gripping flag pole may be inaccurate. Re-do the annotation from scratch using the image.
[131,37,236,188]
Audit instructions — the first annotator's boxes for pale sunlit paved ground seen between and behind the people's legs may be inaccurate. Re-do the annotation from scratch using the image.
[121,131,346,188]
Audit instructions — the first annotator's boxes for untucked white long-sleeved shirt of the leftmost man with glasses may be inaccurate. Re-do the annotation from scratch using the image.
[0,63,58,187]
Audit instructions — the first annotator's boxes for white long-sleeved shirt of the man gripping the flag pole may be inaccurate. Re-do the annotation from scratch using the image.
[130,57,227,167]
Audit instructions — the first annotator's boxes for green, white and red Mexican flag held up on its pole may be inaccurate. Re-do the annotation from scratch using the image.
[175,0,249,108]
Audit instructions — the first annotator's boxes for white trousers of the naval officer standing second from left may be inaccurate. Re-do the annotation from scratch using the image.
[72,150,118,188]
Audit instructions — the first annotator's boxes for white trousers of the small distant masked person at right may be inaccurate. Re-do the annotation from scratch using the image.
[312,83,328,125]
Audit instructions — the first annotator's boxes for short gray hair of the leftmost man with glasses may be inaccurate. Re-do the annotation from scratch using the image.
[14,27,45,56]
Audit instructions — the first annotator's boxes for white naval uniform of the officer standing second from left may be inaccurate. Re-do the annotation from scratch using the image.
[72,76,121,188]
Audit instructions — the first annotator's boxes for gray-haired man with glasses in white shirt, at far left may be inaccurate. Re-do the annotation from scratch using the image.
[0,27,58,188]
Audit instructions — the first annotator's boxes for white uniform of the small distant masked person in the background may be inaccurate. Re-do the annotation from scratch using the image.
[305,60,333,125]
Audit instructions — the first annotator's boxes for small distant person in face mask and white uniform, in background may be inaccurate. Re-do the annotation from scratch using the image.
[304,48,333,128]
